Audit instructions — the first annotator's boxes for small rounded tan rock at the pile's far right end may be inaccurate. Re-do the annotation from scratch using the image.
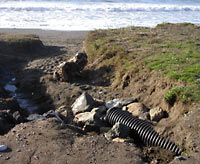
[149,107,165,122]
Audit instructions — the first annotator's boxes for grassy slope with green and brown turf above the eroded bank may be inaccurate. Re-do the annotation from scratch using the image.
[85,23,200,102]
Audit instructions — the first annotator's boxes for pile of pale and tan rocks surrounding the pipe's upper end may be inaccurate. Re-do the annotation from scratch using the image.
[54,92,167,140]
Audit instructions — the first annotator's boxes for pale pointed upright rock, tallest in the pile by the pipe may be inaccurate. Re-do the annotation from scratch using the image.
[71,92,96,115]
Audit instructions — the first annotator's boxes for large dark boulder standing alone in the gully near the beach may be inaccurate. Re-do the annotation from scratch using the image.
[53,52,88,82]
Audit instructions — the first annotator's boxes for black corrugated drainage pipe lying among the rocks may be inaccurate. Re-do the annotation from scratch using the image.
[105,108,181,155]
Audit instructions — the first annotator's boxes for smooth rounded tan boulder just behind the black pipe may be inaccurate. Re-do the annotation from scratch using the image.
[127,103,148,116]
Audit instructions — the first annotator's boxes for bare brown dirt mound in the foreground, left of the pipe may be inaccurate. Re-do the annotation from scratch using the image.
[0,119,142,164]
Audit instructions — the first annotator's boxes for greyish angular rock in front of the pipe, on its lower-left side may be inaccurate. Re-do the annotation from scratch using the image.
[104,122,130,140]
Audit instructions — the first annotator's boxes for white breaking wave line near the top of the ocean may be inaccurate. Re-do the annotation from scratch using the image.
[0,3,200,12]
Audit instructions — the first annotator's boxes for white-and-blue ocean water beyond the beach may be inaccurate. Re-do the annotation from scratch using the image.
[0,0,200,31]
